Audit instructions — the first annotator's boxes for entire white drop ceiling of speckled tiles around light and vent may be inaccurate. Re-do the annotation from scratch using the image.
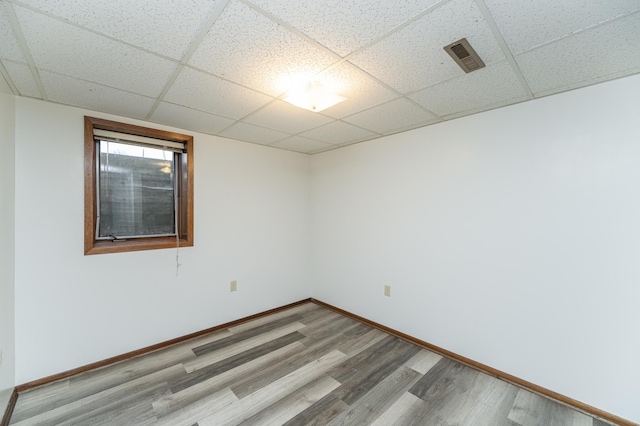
[0,0,640,154]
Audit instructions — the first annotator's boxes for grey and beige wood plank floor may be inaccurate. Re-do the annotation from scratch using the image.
[10,303,609,426]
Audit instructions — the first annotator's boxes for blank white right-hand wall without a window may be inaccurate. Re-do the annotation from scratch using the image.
[312,75,640,422]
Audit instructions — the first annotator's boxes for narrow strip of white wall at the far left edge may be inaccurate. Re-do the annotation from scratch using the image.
[0,93,16,417]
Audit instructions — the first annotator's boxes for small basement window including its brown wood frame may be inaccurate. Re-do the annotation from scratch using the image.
[84,117,193,254]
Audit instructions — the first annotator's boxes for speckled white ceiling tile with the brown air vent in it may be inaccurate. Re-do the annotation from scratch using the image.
[349,0,505,93]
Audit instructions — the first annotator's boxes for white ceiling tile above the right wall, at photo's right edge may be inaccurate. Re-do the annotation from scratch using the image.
[516,13,640,96]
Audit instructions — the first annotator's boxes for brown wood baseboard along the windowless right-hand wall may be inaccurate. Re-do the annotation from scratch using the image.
[311,298,640,426]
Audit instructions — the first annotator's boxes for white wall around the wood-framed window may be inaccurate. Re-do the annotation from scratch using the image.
[15,98,310,383]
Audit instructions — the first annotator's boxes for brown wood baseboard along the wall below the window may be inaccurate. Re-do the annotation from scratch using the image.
[15,299,312,392]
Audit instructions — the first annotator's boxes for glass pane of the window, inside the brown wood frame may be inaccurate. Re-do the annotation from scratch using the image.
[98,141,175,238]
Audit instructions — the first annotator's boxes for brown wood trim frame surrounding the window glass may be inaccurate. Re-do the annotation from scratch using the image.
[84,116,193,255]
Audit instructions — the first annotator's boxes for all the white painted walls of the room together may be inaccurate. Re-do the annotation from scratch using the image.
[10,76,640,422]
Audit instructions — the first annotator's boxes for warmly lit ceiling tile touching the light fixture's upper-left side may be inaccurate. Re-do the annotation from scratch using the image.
[189,0,337,96]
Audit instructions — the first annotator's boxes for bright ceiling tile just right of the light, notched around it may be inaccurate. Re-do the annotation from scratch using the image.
[318,63,397,118]
